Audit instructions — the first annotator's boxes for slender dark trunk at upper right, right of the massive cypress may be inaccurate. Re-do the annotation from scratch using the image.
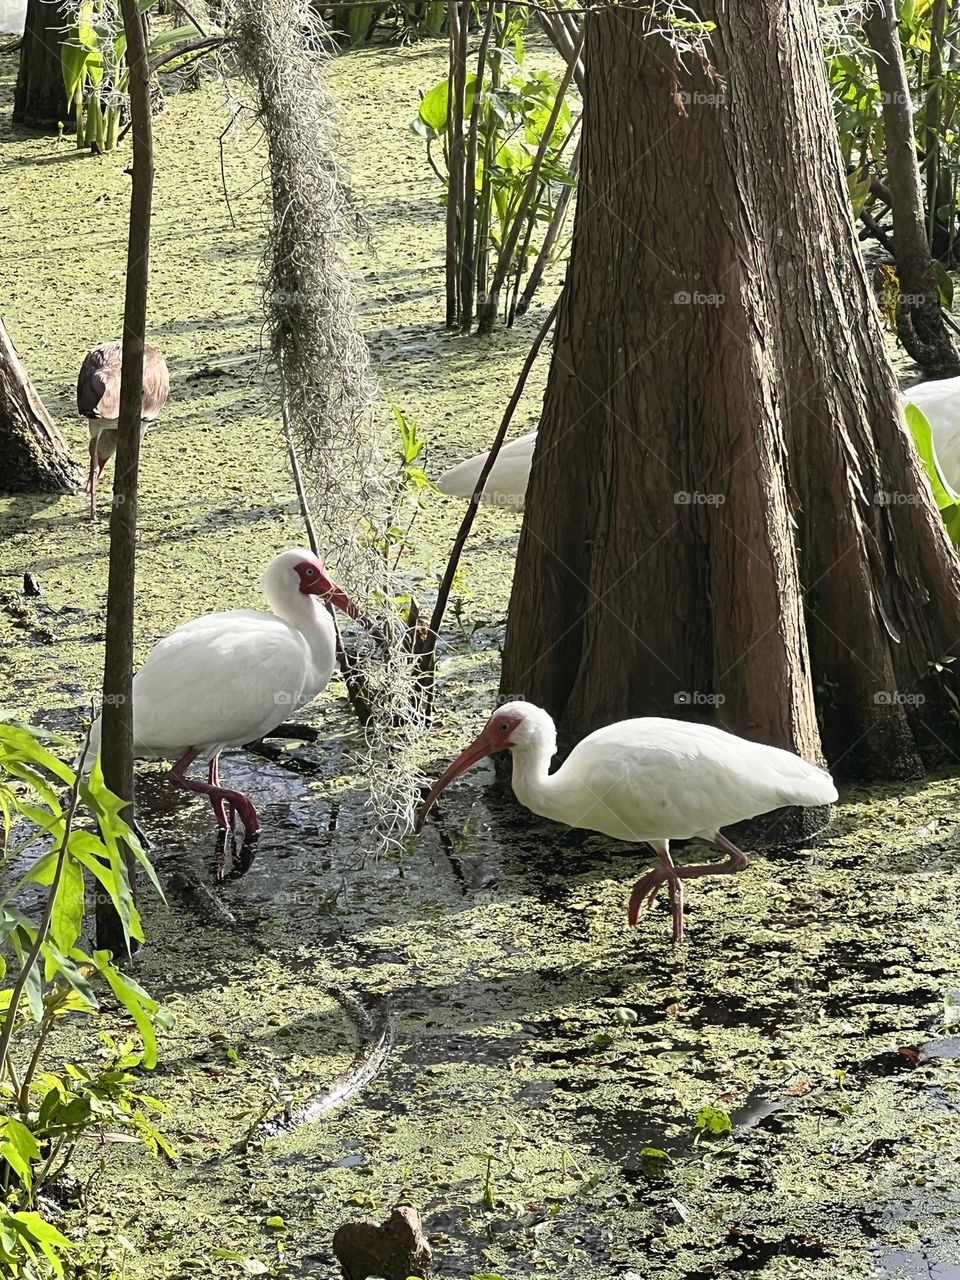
[864,0,960,374]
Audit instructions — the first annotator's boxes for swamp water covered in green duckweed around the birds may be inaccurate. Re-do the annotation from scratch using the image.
[0,35,960,1280]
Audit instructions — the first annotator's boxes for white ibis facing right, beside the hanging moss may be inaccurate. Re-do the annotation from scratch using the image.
[87,548,361,835]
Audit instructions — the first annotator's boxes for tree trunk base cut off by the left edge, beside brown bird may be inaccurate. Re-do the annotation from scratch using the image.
[0,320,79,494]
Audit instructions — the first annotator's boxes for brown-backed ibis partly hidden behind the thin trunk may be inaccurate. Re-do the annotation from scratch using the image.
[77,342,170,520]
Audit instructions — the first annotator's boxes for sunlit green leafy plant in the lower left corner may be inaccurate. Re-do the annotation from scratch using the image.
[0,721,172,1280]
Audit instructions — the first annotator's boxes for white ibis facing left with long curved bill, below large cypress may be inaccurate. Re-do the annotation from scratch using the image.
[420,701,837,942]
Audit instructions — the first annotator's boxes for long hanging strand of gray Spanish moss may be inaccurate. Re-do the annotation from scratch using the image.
[225,0,421,838]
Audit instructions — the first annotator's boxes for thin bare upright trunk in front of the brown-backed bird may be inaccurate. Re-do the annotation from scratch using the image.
[96,0,154,955]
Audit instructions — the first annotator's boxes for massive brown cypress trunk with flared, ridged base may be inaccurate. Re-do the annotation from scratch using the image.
[502,0,960,776]
